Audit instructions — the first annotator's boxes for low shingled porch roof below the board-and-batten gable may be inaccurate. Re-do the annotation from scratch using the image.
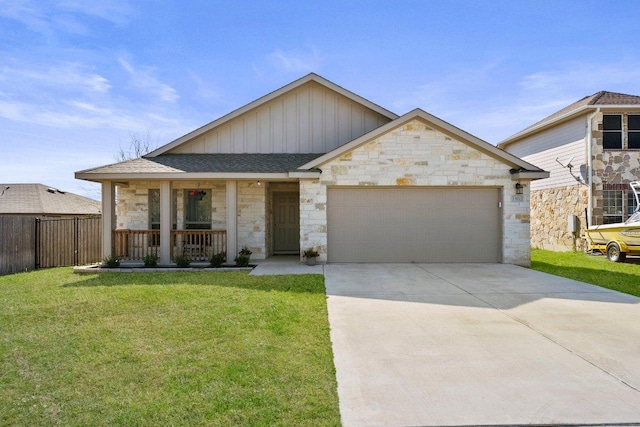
[76,153,321,180]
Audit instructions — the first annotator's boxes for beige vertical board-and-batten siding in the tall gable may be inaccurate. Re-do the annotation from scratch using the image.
[169,82,390,154]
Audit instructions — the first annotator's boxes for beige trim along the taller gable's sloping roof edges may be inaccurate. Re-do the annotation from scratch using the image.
[144,73,398,158]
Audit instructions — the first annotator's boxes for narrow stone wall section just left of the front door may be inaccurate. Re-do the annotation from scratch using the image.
[235,181,267,260]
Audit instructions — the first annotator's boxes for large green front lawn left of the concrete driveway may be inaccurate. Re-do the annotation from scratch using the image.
[0,268,340,426]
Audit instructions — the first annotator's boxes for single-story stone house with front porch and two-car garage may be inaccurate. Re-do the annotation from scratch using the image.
[76,74,548,265]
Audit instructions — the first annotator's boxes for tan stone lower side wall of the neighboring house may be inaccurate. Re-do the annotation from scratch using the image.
[531,185,588,251]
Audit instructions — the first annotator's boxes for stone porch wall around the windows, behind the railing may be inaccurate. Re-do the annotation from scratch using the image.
[116,181,227,230]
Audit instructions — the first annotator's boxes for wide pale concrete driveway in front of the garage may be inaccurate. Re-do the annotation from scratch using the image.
[325,264,640,426]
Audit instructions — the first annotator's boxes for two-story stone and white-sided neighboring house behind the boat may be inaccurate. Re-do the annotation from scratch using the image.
[498,91,640,251]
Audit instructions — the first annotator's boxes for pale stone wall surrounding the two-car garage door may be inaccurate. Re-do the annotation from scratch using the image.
[300,120,530,266]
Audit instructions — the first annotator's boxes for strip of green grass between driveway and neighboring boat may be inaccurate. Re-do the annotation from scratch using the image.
[531,249,640,297]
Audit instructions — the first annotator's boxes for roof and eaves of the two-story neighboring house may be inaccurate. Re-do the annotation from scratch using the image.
[498,91,640,148]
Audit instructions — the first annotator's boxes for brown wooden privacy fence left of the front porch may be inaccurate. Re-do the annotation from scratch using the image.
[0,216,102,275]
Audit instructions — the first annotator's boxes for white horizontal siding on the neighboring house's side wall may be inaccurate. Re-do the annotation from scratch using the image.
[506,116,587,190]
